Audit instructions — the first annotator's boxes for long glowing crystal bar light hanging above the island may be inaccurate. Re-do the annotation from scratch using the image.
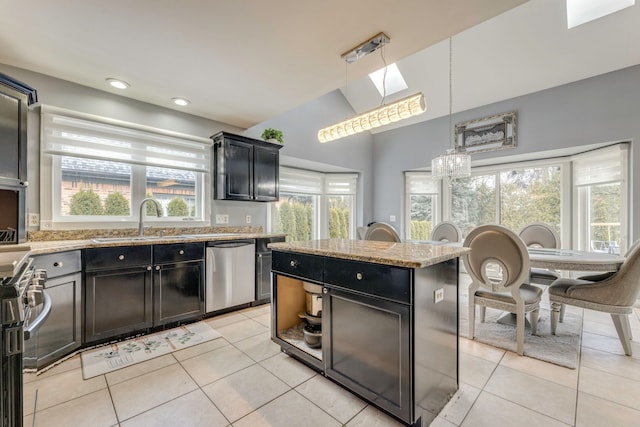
[318,92,427,143]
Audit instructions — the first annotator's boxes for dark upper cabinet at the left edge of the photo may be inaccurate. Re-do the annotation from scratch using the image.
[0,73,36,186]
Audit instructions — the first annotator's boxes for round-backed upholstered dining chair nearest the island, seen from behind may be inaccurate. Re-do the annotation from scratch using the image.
[462,225,542,355]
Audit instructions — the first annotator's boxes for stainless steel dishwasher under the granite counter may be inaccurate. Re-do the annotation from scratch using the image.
[205,240,256,313]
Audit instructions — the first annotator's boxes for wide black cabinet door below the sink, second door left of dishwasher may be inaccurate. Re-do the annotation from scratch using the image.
[84,266,153,342]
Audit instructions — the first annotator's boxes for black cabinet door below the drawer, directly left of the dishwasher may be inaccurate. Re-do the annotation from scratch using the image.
[153,261,204,326]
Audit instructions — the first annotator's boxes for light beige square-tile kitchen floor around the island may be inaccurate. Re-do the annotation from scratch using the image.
[24,290,640,427]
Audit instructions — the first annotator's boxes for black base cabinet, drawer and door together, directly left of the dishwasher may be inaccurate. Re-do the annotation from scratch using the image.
[153,243,204,326]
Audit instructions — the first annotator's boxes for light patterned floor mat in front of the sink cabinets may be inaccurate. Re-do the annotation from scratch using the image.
[80,322,222,380]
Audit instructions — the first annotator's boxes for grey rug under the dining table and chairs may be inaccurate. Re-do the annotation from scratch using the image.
[460,302,582,369]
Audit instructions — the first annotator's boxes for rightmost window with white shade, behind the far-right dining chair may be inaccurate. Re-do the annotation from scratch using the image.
[573,144,630,254]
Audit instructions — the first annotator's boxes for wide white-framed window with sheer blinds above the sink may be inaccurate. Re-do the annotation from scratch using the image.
[41,106,211,228]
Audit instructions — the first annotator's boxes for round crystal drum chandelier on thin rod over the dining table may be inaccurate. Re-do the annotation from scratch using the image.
[431,37,471,180]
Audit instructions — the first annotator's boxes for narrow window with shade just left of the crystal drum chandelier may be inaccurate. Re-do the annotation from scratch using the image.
[405,172,440,240]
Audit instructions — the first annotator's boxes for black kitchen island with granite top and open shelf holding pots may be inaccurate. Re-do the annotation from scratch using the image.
[270,239,468,425]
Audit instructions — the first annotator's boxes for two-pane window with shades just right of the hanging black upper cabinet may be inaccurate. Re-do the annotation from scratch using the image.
[271,167,358,241]
